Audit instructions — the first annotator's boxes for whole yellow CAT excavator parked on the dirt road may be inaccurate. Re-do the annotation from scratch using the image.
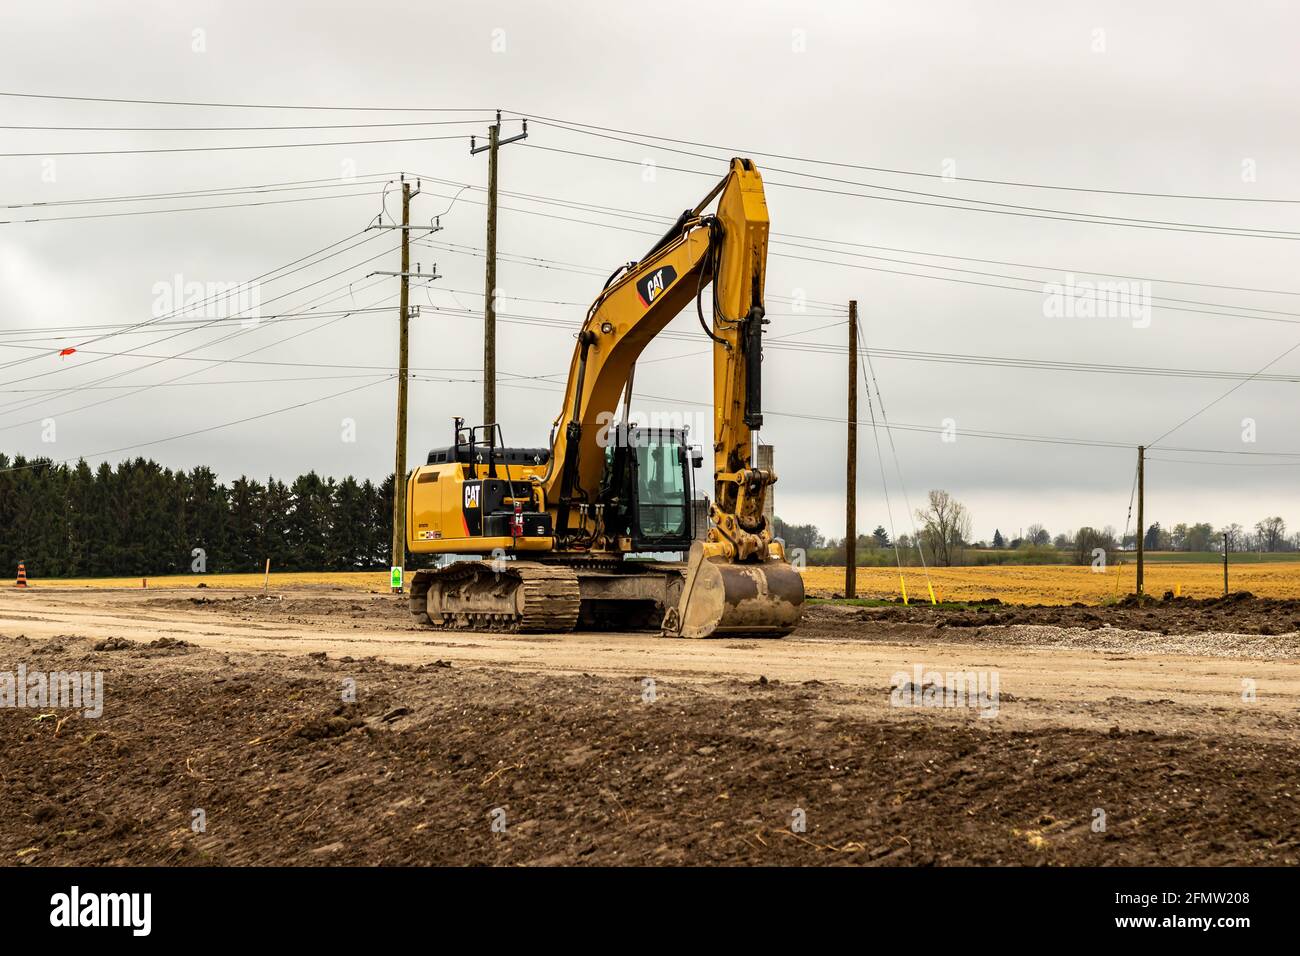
[406,159,803,637]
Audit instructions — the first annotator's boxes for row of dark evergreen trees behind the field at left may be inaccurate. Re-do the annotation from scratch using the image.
[0,454,393,578]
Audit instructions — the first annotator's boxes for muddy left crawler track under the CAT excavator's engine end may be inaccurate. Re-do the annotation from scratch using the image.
[411,561,580,633]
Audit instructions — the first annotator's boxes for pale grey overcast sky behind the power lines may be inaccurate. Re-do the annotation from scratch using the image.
[0,0,1300,538]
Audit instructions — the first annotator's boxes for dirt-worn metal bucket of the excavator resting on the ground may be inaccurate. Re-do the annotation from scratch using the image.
[663,541,803,637]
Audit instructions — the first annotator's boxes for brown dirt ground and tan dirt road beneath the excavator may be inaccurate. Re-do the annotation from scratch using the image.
[0,589,1300,864]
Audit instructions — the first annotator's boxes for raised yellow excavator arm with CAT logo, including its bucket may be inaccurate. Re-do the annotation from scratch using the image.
[537,159,803,636]
